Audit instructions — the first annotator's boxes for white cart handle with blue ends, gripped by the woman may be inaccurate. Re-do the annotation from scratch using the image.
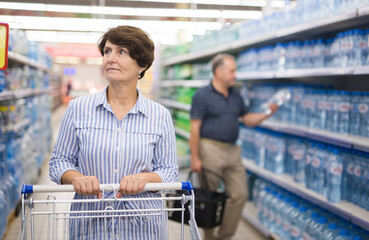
[22,181,193,194]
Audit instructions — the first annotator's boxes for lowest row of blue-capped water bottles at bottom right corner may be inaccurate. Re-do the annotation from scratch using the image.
[252,178,369,240]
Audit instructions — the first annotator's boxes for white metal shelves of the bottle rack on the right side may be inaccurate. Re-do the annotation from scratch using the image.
[159,6,369,237]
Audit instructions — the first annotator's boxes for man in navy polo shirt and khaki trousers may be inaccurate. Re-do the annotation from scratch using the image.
[190,54,278,240]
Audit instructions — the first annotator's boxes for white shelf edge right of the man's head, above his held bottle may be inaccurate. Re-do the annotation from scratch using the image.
[237,65,369,80]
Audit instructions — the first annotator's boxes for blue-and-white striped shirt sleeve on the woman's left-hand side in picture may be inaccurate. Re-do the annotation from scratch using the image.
[49,101,79,184]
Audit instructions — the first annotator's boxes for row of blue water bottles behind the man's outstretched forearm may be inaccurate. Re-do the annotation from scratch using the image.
[241,84,369,137]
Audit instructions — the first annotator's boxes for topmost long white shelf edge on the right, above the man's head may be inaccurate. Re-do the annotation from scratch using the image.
[163,7,369,66]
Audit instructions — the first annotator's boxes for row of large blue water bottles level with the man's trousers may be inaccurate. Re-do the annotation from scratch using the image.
[240,126,369,206]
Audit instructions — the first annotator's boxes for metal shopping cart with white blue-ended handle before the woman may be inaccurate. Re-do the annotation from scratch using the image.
[21,182,201,240]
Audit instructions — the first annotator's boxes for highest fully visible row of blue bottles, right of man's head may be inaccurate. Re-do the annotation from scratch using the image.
[237,29,369,72]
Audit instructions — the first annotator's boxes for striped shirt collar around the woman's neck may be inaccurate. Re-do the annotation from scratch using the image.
[96,85,147,116]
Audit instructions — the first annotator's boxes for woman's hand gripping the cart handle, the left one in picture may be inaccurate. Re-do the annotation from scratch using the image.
[72,176,102,199]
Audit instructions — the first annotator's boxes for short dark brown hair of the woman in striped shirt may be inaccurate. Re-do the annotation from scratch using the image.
[98,25,155,79]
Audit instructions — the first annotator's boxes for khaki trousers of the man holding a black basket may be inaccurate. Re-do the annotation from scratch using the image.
[199,138,248,240]
